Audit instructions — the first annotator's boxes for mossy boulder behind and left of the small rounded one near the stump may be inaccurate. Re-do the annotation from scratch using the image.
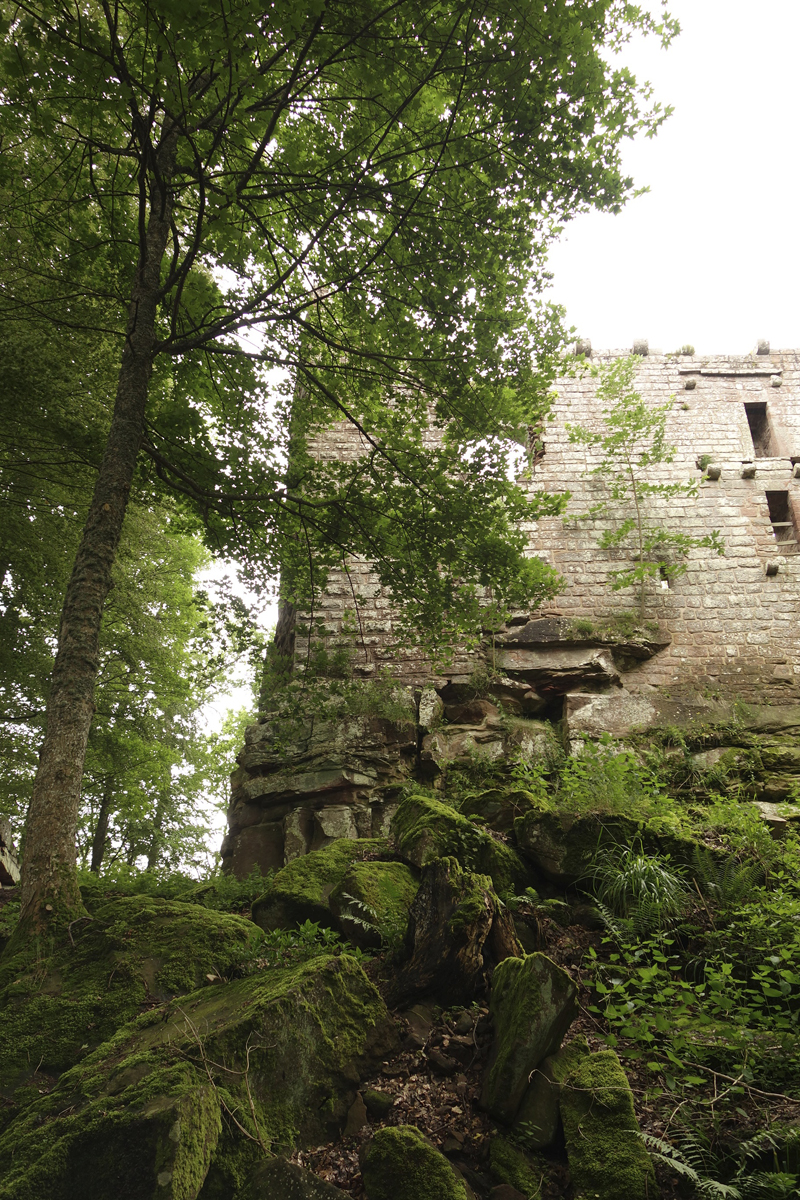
[253,838,390,930]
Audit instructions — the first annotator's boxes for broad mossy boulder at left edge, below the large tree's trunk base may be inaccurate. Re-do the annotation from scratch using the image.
[0,895,261,1099]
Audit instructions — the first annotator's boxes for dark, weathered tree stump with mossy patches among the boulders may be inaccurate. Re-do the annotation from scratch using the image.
[389,858,521,1007]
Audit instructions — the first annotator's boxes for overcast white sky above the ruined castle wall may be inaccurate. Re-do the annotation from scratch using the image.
[551,0,800,354]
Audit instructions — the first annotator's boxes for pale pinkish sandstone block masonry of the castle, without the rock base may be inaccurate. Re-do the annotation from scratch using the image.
[291,350,800,702]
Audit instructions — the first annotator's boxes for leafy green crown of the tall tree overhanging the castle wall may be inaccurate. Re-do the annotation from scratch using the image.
[0,0,675,625]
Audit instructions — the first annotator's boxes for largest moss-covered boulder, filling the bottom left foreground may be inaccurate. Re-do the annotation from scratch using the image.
[0,955,397,1200]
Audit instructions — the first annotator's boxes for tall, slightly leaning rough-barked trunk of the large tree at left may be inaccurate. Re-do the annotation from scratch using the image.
[20,131,178,926]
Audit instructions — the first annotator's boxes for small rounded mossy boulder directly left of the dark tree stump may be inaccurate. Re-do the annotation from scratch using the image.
[329,862,420,947]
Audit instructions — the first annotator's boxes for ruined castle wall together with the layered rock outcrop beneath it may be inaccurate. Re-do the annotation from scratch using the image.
[222,352,800,875]
